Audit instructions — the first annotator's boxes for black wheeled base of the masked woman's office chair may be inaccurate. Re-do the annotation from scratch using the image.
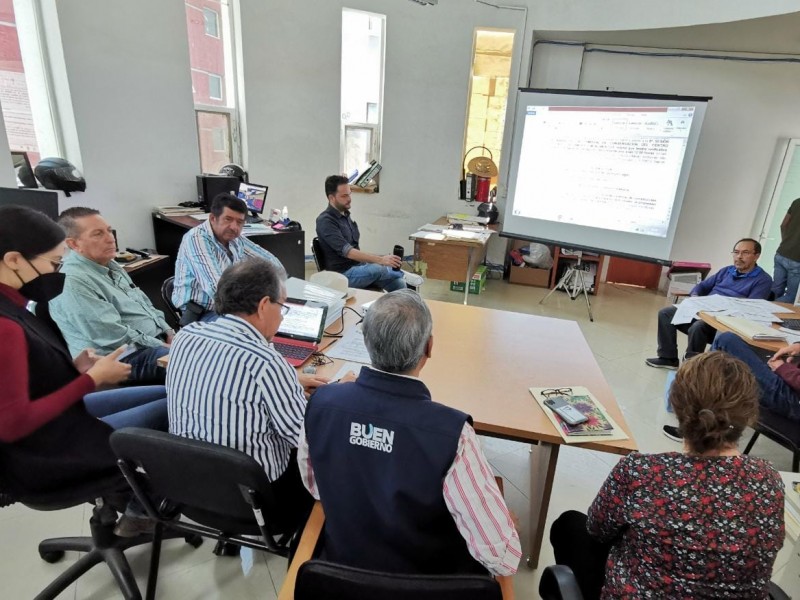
[0,479,202,600]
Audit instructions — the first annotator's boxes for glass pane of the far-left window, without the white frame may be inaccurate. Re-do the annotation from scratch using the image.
[0,0,41,166]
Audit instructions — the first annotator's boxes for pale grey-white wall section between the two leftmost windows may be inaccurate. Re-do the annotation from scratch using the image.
[49,0,199,247]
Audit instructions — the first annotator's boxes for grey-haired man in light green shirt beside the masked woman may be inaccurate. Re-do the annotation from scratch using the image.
[49,207,175,383]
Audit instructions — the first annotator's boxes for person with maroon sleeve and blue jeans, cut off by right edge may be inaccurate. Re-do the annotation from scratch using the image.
[711,332,800,423]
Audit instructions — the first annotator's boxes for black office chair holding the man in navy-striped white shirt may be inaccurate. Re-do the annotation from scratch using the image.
[111,427,308,599]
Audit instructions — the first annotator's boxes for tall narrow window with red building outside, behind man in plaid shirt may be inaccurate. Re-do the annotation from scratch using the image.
[185,0,242,173]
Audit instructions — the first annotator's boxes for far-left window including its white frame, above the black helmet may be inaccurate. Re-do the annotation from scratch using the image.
[0,0,63,173]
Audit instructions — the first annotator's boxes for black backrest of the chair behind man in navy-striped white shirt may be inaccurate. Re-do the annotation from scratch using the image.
[111,427,284,530]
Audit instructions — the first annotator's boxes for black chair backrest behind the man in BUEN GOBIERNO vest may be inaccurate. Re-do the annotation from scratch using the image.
[294,560,502,600]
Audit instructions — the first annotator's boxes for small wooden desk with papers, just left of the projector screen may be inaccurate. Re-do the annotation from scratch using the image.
[409,217,488,304]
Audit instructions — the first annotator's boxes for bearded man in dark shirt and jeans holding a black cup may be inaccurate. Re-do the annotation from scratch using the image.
[317,175,422,292]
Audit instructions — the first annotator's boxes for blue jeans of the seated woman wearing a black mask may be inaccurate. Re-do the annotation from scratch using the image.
[83,385,169,431]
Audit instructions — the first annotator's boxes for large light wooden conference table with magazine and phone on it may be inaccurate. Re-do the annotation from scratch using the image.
[160,290,636,568]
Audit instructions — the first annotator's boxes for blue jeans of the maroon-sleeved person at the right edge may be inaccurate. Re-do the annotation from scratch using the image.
[711,332,800,421]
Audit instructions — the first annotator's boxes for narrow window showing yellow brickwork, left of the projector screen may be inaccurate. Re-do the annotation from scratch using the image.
[462,29,514,178]
